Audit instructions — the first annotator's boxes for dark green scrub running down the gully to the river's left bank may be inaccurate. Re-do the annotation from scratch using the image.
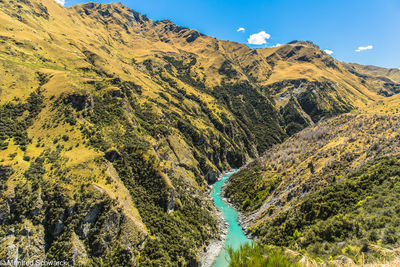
[114,151,216,266]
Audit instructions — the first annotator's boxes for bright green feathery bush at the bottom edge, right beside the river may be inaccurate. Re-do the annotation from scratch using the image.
[228,243,301,267]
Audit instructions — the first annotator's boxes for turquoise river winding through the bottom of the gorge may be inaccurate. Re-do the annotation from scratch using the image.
[211,171,250,267]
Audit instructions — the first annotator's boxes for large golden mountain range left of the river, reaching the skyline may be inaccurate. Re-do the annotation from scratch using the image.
[0,0,399,266]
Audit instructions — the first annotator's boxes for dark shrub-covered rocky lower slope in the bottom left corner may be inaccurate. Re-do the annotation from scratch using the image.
[0,151,144,266]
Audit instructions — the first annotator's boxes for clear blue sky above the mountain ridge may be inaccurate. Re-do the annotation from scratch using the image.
[65,0,400,68]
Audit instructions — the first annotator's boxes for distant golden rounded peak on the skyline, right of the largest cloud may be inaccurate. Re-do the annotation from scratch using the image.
[261,41,380,109]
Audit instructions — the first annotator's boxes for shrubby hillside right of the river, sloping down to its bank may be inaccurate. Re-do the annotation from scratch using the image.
[225,96,400,264]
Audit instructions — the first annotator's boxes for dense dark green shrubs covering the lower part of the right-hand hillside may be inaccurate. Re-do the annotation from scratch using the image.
[253,157,400,263]
